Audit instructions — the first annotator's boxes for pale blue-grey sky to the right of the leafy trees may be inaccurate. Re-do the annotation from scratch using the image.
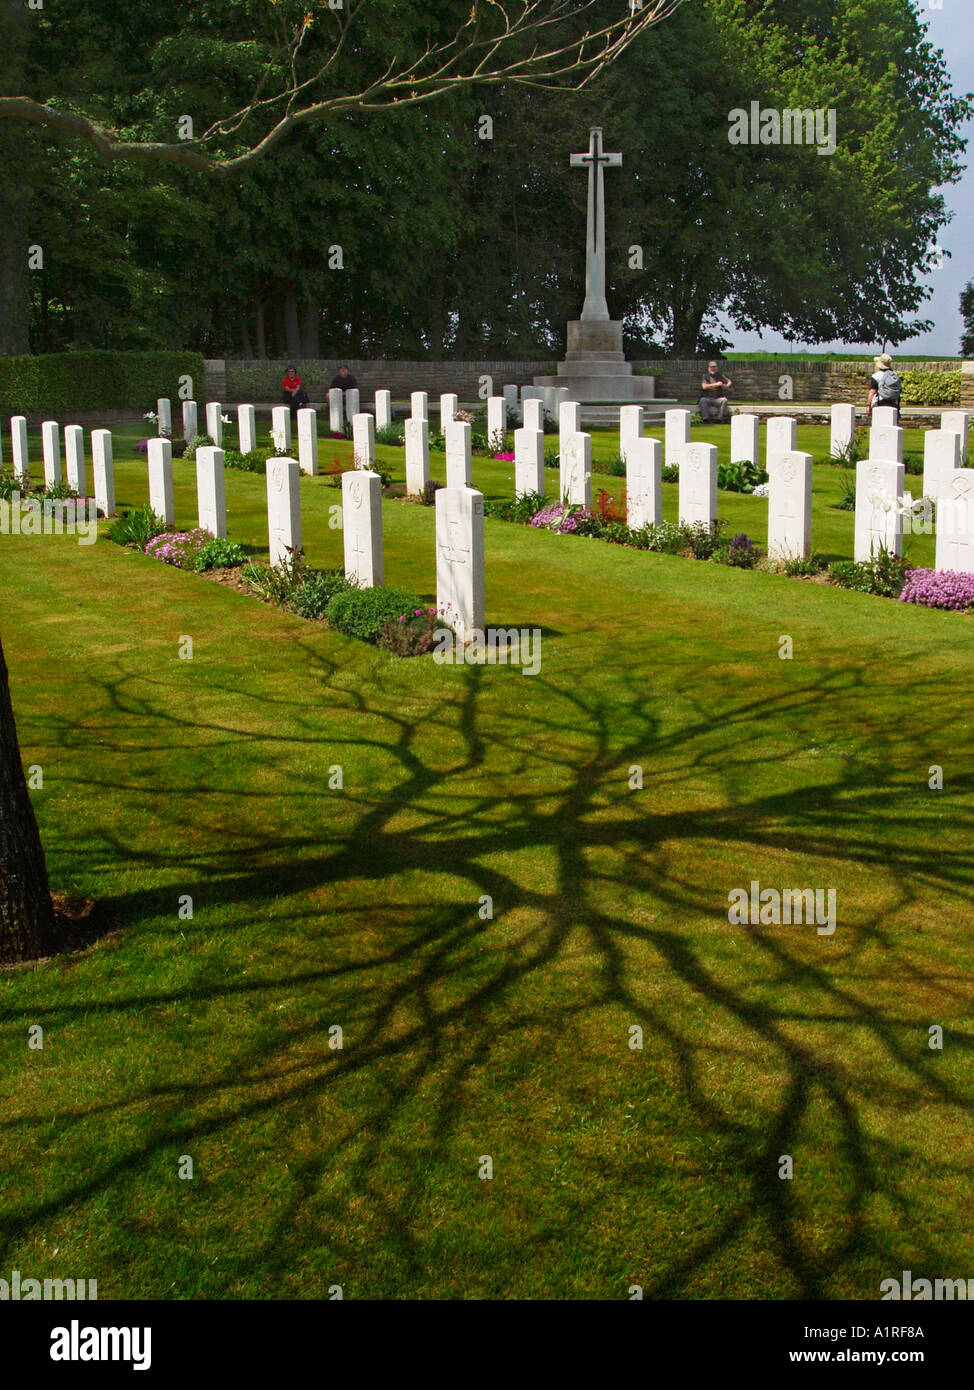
[725,0,974,359]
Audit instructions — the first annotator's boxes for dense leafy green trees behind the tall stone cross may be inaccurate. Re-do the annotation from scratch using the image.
[0,0,971,357]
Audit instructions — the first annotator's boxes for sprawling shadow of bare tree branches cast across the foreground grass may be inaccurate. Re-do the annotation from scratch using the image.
[0,638,974,1298]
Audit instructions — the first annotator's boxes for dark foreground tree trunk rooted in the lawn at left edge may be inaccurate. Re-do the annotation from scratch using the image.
[0,633,56,960]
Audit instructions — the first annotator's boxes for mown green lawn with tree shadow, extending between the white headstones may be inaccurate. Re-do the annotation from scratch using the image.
[0,417,974,1298]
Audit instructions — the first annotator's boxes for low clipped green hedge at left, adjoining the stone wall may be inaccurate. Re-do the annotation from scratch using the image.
[0,352,206,423]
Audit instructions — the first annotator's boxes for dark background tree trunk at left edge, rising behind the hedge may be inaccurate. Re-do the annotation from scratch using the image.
[0,0,31,357]
